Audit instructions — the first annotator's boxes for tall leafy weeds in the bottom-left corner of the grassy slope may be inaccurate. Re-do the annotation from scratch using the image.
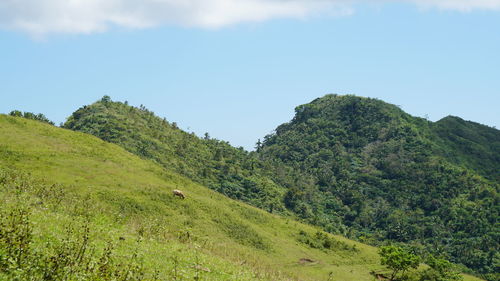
[0,207,145,281]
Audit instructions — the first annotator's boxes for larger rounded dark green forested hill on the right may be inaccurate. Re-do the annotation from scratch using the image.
[259,95,500,280]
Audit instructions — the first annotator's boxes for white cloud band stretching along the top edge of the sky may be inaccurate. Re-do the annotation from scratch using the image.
[0,0,500,36]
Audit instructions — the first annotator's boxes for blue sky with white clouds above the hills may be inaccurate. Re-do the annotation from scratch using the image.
[0,0,500,150]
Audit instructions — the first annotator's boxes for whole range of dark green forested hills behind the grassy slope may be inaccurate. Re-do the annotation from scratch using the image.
[64,95,500,280]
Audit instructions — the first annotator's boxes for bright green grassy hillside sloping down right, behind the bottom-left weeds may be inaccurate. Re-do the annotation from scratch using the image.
[0,115,479,281]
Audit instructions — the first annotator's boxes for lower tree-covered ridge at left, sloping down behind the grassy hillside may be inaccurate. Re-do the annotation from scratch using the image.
[63,96,285,212]
